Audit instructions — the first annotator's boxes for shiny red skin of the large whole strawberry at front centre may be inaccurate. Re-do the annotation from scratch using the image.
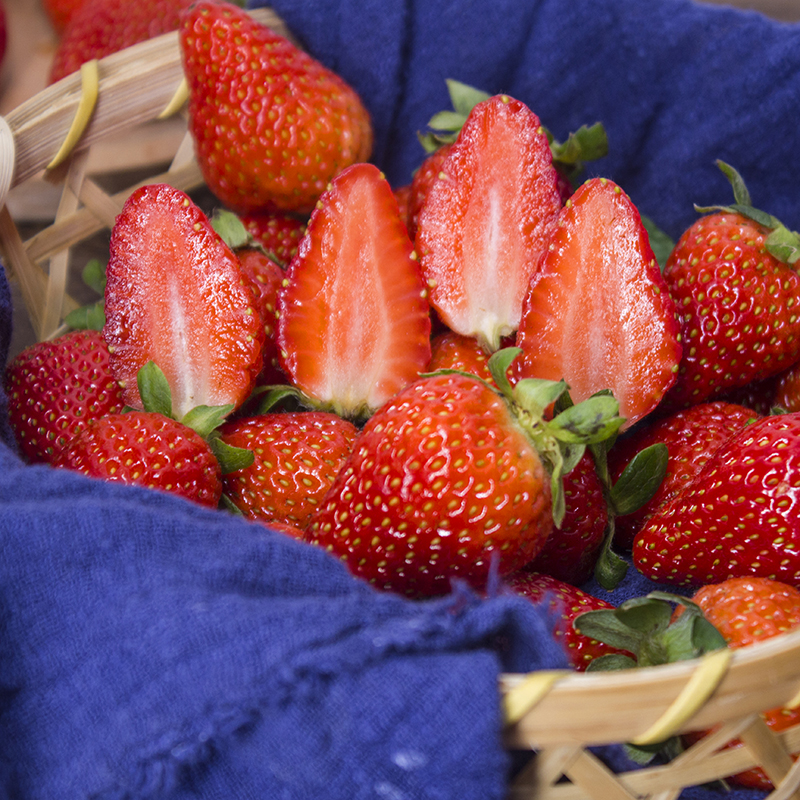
[307,374,552,596]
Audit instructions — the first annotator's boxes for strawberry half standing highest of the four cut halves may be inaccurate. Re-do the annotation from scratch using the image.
[416,95,561,352]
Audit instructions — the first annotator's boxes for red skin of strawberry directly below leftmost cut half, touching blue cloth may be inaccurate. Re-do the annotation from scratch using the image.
[55,411,222,508]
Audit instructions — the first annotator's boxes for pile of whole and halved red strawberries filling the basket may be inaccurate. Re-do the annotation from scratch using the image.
[10,0,800,780]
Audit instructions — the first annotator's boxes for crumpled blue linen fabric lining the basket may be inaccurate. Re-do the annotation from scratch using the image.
[0,0,800,800]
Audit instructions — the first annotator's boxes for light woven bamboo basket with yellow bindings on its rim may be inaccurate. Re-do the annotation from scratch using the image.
[0,10,800,800]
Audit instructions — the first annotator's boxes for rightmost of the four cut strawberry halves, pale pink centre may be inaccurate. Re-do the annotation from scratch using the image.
[517,178,681,427]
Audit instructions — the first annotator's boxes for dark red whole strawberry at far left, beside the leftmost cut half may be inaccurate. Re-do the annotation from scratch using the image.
[4,331,125,463]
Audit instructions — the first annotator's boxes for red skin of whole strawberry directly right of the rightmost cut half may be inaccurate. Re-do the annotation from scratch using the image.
[664,213,800,407]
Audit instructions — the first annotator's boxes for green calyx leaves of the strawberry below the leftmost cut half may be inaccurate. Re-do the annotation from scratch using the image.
[136,361,254,475]
